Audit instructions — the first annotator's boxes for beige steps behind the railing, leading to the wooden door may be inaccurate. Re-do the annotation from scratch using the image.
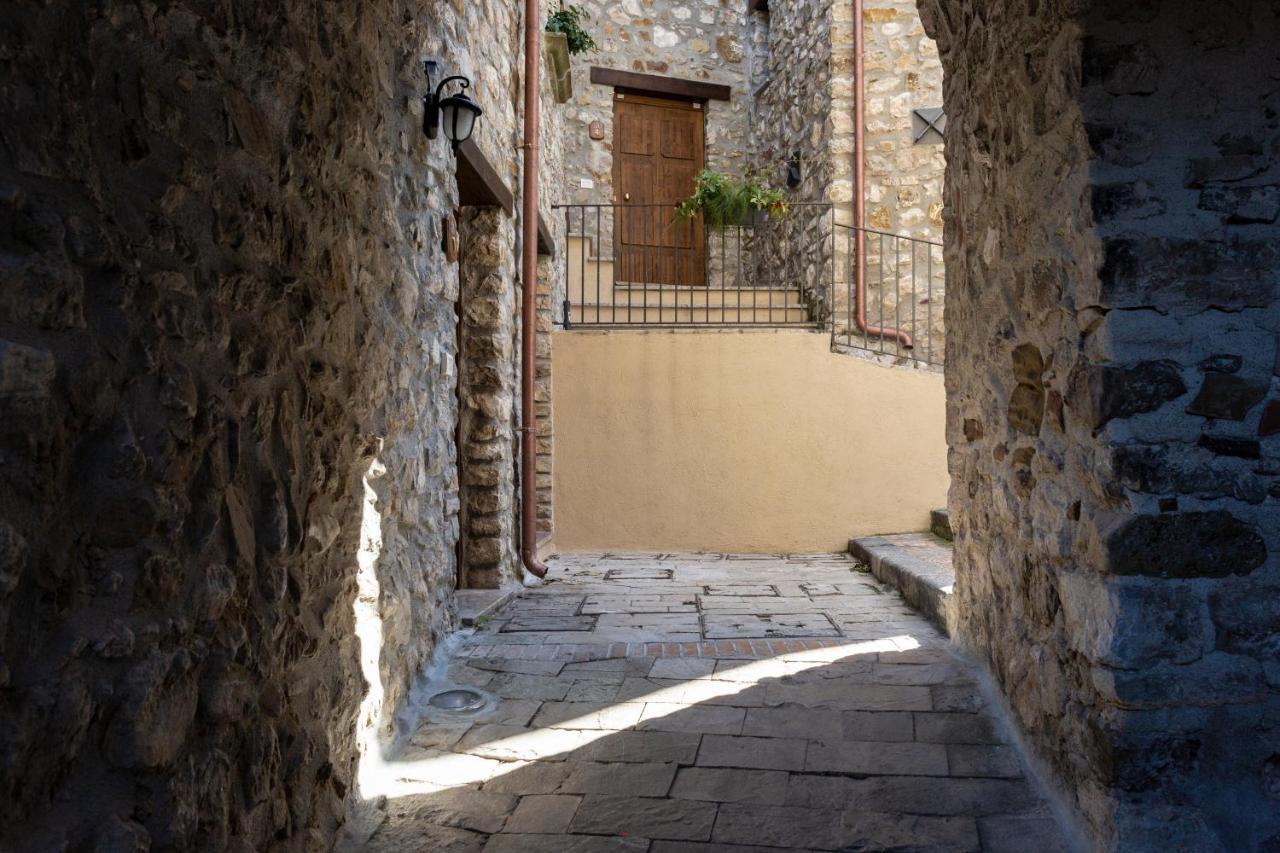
[557,234,810,325]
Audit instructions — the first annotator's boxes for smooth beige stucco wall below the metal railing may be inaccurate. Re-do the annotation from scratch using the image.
[552,330,948,552]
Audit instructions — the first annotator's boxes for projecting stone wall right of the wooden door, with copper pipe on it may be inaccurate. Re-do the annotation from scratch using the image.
[751,0,945,338]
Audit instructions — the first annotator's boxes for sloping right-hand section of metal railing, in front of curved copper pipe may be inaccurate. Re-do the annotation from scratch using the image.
[831,223,945,366]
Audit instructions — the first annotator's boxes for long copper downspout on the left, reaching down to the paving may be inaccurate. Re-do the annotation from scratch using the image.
[520,0,547,578]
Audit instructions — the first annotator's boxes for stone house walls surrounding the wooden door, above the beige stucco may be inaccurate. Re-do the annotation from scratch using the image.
[550,0,943,335]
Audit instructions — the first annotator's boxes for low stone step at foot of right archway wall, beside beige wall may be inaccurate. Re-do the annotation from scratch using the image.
[849,533,955,635]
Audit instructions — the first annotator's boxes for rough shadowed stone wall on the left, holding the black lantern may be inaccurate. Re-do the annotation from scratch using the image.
[0,0,545,850]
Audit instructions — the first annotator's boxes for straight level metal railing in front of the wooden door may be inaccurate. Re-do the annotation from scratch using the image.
[557,202,836,329]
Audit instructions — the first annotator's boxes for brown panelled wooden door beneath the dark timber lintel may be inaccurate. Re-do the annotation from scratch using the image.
[613,92,707,287]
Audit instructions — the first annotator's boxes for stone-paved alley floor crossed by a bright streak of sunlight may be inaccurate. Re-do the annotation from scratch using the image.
[366,555,1068,853]
